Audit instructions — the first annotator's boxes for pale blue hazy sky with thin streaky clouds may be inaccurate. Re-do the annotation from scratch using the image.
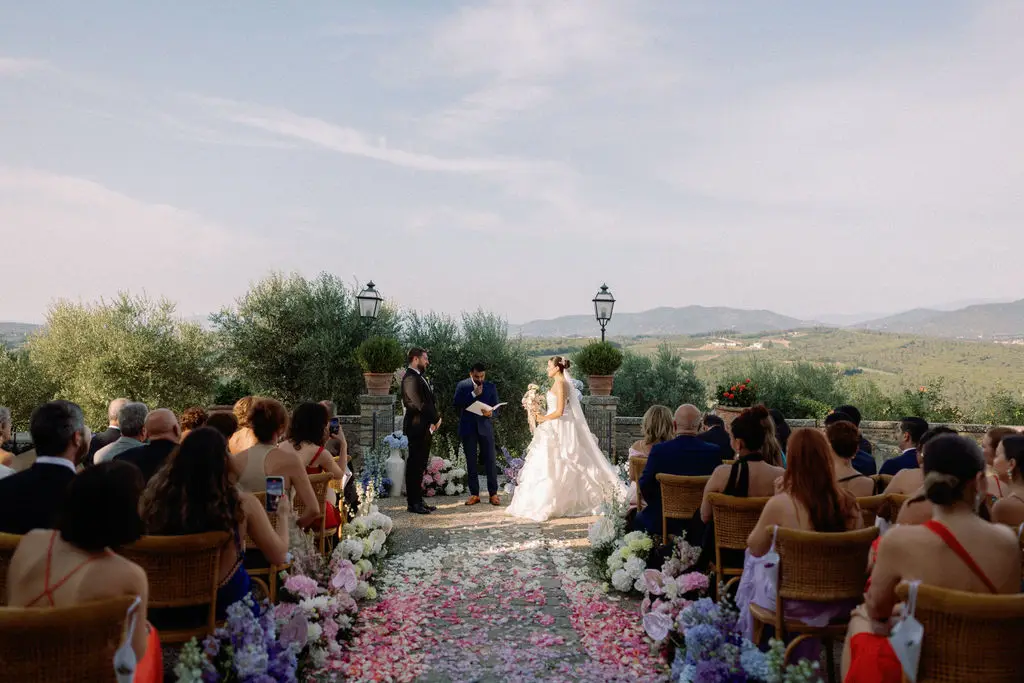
[0,0,1024,322]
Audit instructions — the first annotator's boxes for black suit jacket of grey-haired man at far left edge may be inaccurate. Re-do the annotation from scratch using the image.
[0,463,75,535]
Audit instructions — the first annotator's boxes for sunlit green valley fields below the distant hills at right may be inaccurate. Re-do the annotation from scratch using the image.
[525,329,1024,405]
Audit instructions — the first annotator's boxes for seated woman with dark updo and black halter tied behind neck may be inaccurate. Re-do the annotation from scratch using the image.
[700,405,785,522]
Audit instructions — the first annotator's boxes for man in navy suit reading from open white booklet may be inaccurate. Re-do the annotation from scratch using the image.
[455,362,501,505]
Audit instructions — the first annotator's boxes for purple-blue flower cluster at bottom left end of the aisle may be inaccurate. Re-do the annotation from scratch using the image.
[174,596,305,683]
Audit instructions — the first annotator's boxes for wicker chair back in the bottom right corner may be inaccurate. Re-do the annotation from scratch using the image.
[896,584,1024,683]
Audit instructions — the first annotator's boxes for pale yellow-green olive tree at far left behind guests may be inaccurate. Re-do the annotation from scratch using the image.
[20,294,215,427]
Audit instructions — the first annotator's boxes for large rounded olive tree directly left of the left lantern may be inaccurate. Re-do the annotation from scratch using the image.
[212,273,398,414]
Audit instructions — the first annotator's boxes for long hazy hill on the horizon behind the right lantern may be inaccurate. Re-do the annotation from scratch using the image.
[512,306,814,337]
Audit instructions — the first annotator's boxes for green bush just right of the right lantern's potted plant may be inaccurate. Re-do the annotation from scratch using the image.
[612,344,707,416]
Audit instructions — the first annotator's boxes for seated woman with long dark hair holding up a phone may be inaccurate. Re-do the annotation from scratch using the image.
[141,427,291,626]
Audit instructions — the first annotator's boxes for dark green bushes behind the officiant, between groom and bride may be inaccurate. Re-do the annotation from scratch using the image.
[404,311,534,452]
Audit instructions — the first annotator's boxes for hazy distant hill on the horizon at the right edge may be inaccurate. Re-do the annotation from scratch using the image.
[855,299,1024,340]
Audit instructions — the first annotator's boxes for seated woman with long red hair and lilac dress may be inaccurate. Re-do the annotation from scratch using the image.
[736,429,864,638]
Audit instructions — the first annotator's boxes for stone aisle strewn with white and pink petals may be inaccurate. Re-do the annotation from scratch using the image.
[334,495,668,682]
